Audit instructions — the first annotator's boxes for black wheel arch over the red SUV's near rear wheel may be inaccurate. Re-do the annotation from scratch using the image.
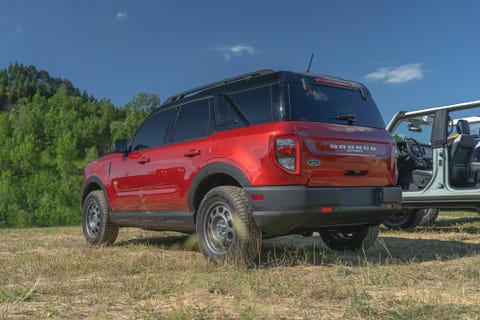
[187,162,250,215]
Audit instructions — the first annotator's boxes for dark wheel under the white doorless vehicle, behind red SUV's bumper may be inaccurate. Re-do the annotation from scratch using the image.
[383,208,440,230]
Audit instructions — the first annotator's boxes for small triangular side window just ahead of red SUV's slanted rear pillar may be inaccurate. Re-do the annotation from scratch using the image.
[213,94,248,131]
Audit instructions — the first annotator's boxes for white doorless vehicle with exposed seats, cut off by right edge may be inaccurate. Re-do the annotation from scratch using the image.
[384,101,480,228]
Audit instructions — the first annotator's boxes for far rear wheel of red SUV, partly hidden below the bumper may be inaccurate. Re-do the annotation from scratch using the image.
[320,226,379,251]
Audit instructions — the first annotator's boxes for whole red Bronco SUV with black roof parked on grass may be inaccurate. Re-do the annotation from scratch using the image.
[82,70,401,263]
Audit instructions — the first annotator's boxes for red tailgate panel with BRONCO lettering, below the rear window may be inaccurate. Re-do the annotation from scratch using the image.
[295,121,397,187]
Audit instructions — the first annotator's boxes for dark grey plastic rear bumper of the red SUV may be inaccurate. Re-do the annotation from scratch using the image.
[244,186,402,235]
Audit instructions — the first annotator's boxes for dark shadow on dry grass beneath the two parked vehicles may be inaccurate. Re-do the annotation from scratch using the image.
[115,233,480,268]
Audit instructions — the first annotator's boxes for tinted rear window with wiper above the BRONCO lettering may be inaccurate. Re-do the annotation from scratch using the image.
[290,84,385,129]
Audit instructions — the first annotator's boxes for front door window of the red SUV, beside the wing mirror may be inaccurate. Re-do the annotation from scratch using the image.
[130,109,173,151]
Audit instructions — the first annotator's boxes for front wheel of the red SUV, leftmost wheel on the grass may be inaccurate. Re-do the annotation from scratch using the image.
[82,190,118,245]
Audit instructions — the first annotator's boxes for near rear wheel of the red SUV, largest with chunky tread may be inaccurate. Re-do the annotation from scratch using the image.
[196,186,262,266]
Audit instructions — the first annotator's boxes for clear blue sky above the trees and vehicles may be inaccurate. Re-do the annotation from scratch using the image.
[0,0,480,122]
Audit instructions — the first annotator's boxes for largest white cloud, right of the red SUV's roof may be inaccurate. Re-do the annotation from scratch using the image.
[363,63,424,84]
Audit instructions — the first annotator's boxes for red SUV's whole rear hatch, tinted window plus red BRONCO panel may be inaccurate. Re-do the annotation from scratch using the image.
[289,83,396,187]
